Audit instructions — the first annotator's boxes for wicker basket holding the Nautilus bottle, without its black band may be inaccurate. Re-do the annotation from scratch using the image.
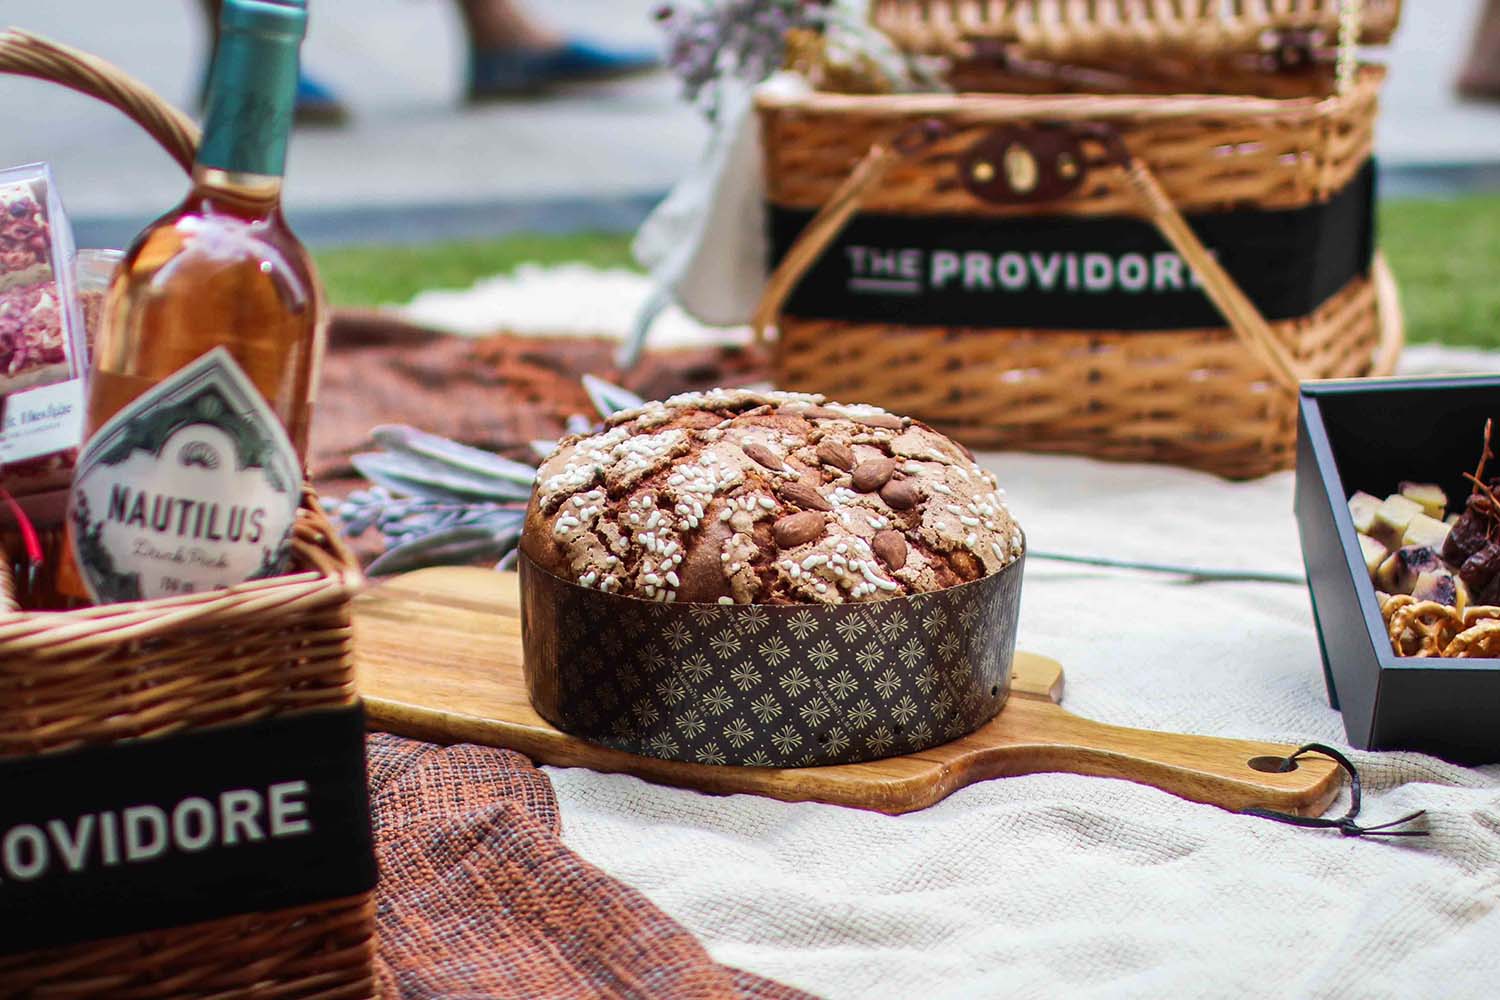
[0,30,375,1000]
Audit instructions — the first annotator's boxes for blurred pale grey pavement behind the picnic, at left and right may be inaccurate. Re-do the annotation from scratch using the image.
[0,0,1500,243]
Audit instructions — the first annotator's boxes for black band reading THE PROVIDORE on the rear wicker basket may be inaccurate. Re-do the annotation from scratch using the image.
[770,160,1376,330]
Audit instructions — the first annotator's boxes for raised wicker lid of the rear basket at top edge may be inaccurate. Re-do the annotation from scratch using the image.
[870,0,1401,61]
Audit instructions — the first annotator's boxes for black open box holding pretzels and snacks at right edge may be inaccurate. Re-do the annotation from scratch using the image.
[1296,375,1500,763]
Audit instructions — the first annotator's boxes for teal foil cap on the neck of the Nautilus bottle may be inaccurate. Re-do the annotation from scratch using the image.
[198,0,308,177]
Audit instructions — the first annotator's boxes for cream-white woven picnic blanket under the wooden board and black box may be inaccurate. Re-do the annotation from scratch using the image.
[408,273,1500,1000]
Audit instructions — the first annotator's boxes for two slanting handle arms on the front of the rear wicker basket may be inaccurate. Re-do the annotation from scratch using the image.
[750,121,1302,393]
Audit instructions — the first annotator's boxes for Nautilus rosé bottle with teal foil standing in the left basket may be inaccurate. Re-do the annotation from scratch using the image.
[63,0,326,603]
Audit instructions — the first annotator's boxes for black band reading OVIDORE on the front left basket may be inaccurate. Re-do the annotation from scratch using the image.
[0,706,375,954]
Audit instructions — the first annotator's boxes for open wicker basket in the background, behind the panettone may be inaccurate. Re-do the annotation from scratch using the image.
[755,1,1403,477]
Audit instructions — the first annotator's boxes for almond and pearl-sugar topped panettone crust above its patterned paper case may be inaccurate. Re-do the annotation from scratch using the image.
[522,390,1023,604]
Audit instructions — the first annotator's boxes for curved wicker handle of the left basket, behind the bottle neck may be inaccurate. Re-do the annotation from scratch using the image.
[0,28,200,172]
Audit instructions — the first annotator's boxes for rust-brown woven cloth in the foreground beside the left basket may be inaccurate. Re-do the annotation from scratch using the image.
[369,733,809,1000]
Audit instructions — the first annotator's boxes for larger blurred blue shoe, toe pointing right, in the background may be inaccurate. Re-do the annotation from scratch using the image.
[468,39,662,100]
